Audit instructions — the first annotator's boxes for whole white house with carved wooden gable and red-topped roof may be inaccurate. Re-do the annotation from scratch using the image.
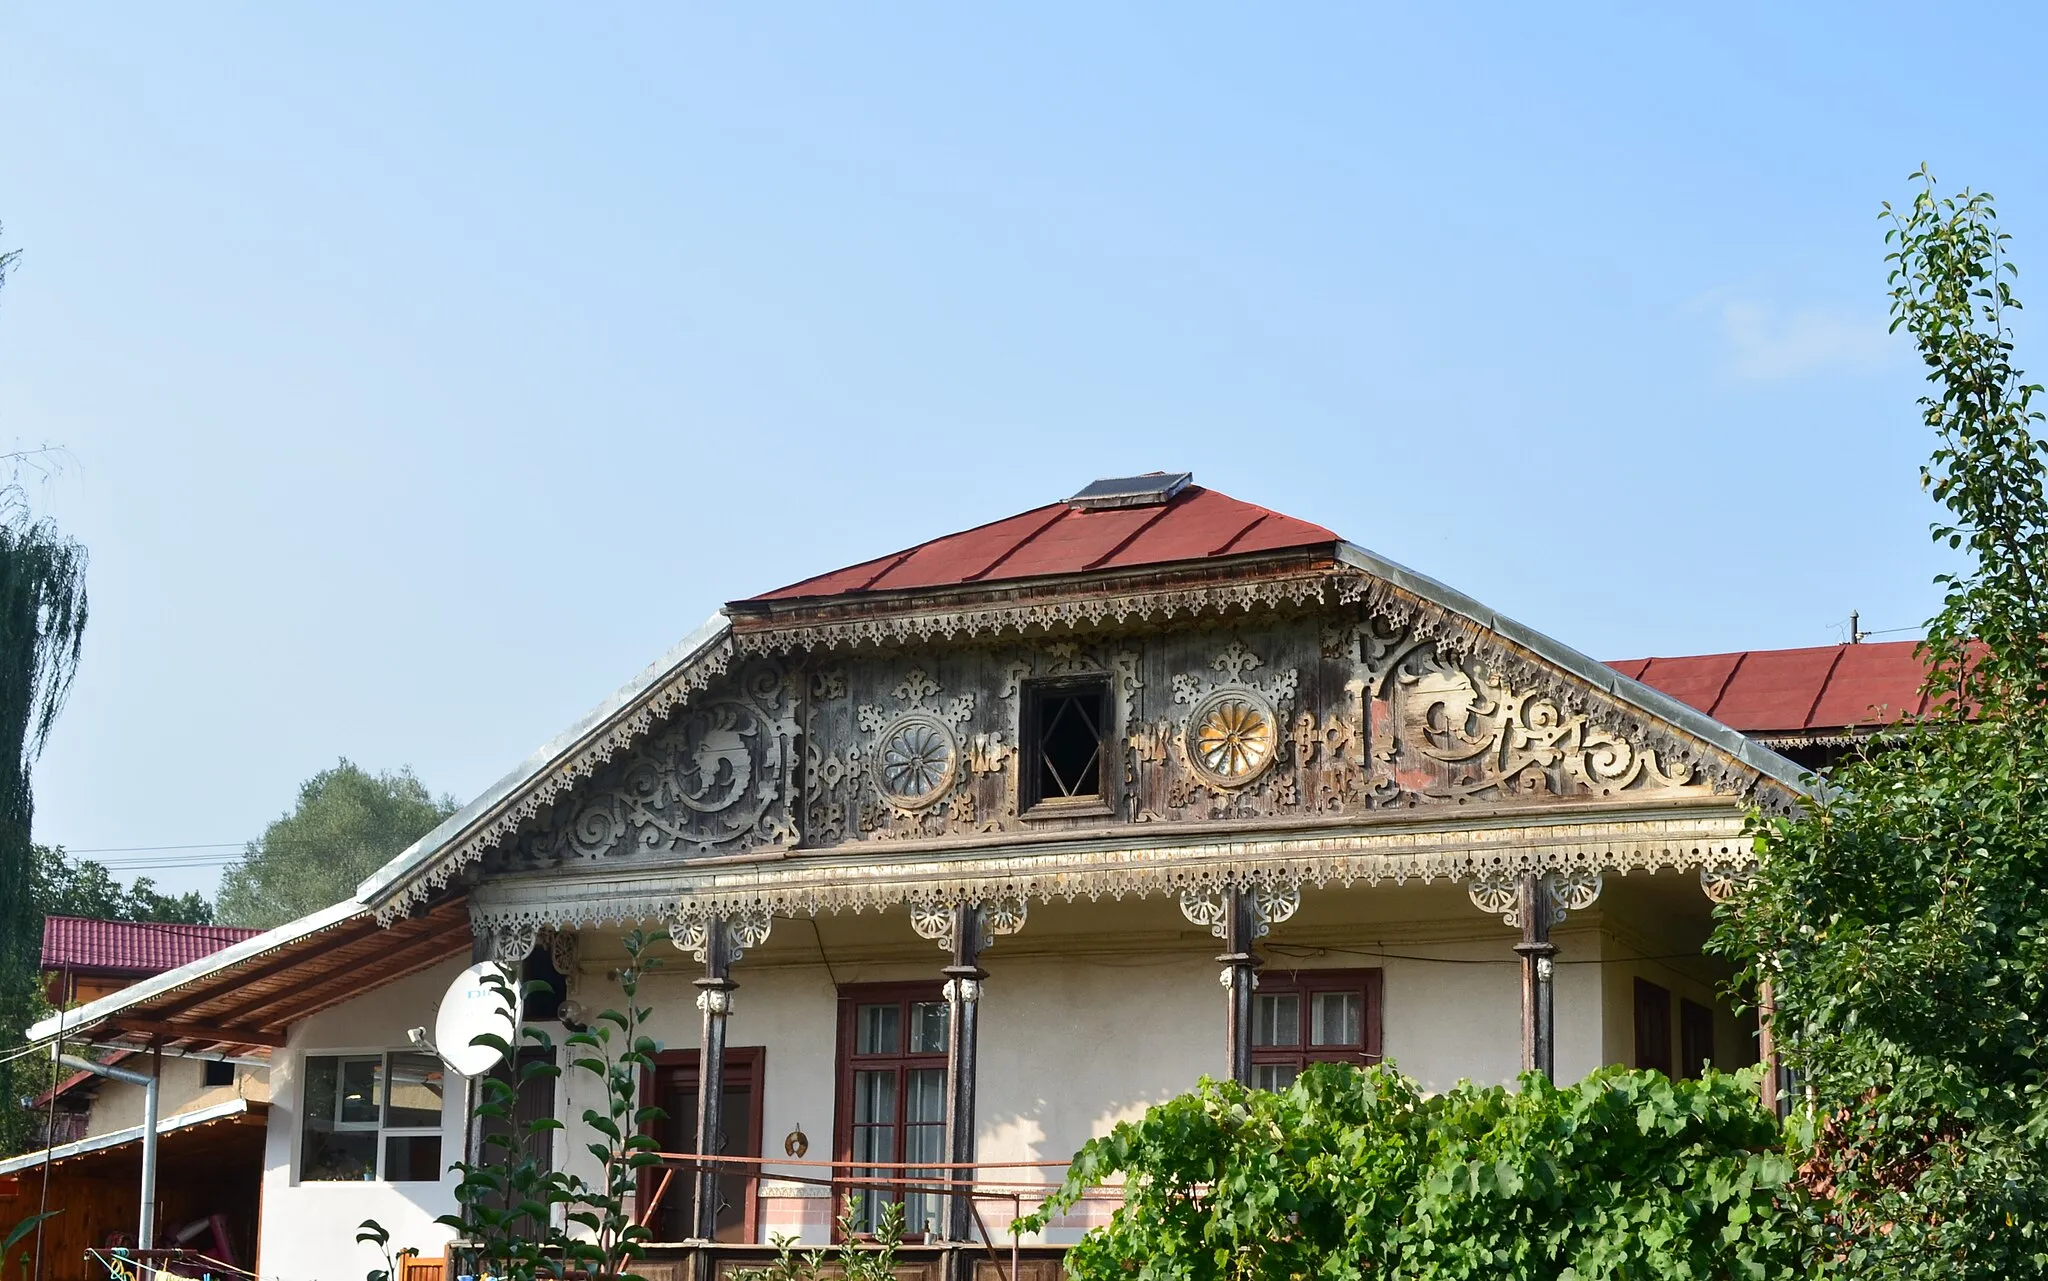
[37,476,1847,1281]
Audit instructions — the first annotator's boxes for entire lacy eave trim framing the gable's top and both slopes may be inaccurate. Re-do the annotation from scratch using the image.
[368,543,1806,924]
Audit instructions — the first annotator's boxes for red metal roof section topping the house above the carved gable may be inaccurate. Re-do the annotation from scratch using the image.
[754,486,1339,601]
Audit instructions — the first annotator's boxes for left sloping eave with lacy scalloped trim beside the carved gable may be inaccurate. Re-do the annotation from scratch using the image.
[356,617,733,924]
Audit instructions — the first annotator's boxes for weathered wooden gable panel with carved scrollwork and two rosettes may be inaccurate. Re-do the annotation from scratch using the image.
[487,590,1749,865]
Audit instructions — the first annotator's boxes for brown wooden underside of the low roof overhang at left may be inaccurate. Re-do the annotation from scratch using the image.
[46,898,471,1056]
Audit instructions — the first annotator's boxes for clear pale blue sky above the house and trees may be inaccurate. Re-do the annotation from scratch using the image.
[0,4,2048,887]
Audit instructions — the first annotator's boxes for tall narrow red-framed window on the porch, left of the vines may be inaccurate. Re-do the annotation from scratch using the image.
[838,984,948,1240]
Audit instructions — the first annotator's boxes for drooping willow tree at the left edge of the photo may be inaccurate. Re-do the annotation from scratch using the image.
[0,227,86,1146]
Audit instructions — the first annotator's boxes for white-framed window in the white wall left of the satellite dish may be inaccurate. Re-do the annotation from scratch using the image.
[299,1051,444,1183]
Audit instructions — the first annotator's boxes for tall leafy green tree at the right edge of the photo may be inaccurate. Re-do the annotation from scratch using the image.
[1714,168,2048,1281]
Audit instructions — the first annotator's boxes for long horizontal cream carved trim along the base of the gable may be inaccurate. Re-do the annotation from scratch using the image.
[471,808,1755,928]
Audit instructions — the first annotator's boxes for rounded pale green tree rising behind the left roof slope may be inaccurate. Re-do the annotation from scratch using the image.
[215,758,455,928]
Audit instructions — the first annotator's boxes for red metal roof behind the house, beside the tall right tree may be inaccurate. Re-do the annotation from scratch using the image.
[1608,642,1927,734]
